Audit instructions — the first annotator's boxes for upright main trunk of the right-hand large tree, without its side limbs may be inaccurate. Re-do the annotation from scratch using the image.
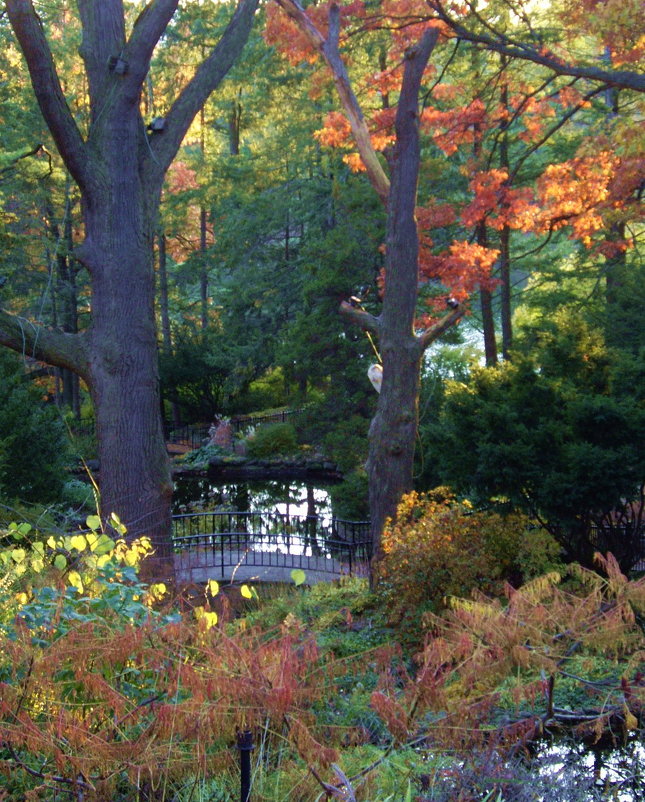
[367,29,442,559]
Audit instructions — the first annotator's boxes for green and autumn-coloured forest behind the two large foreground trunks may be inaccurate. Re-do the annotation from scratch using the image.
[0,2,645,559]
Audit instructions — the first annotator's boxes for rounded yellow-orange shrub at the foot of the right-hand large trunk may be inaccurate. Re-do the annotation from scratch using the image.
[379,488,529,612]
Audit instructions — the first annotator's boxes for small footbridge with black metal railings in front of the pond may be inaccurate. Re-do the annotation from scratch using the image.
[173,511,371,577]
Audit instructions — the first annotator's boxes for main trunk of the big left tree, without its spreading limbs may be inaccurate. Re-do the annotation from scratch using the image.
[85,145,172,561]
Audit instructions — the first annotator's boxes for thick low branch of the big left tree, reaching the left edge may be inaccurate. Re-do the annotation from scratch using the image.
[0,309,89,380]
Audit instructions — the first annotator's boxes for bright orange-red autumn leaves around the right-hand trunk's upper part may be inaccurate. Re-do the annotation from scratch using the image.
[267,0,645,326]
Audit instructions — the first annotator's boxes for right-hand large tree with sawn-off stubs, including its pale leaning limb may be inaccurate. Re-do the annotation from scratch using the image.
[277,0,462,568]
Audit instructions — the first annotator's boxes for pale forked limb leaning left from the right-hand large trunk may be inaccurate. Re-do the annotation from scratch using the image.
[276,0,390,203]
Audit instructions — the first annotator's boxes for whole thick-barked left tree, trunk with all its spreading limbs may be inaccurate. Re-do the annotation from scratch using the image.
[0,0,258,570]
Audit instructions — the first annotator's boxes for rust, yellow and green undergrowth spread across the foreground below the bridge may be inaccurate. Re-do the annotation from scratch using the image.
[0,517,645,802]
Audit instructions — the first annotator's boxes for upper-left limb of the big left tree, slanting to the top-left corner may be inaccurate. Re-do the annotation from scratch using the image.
[6,0,91,189]
